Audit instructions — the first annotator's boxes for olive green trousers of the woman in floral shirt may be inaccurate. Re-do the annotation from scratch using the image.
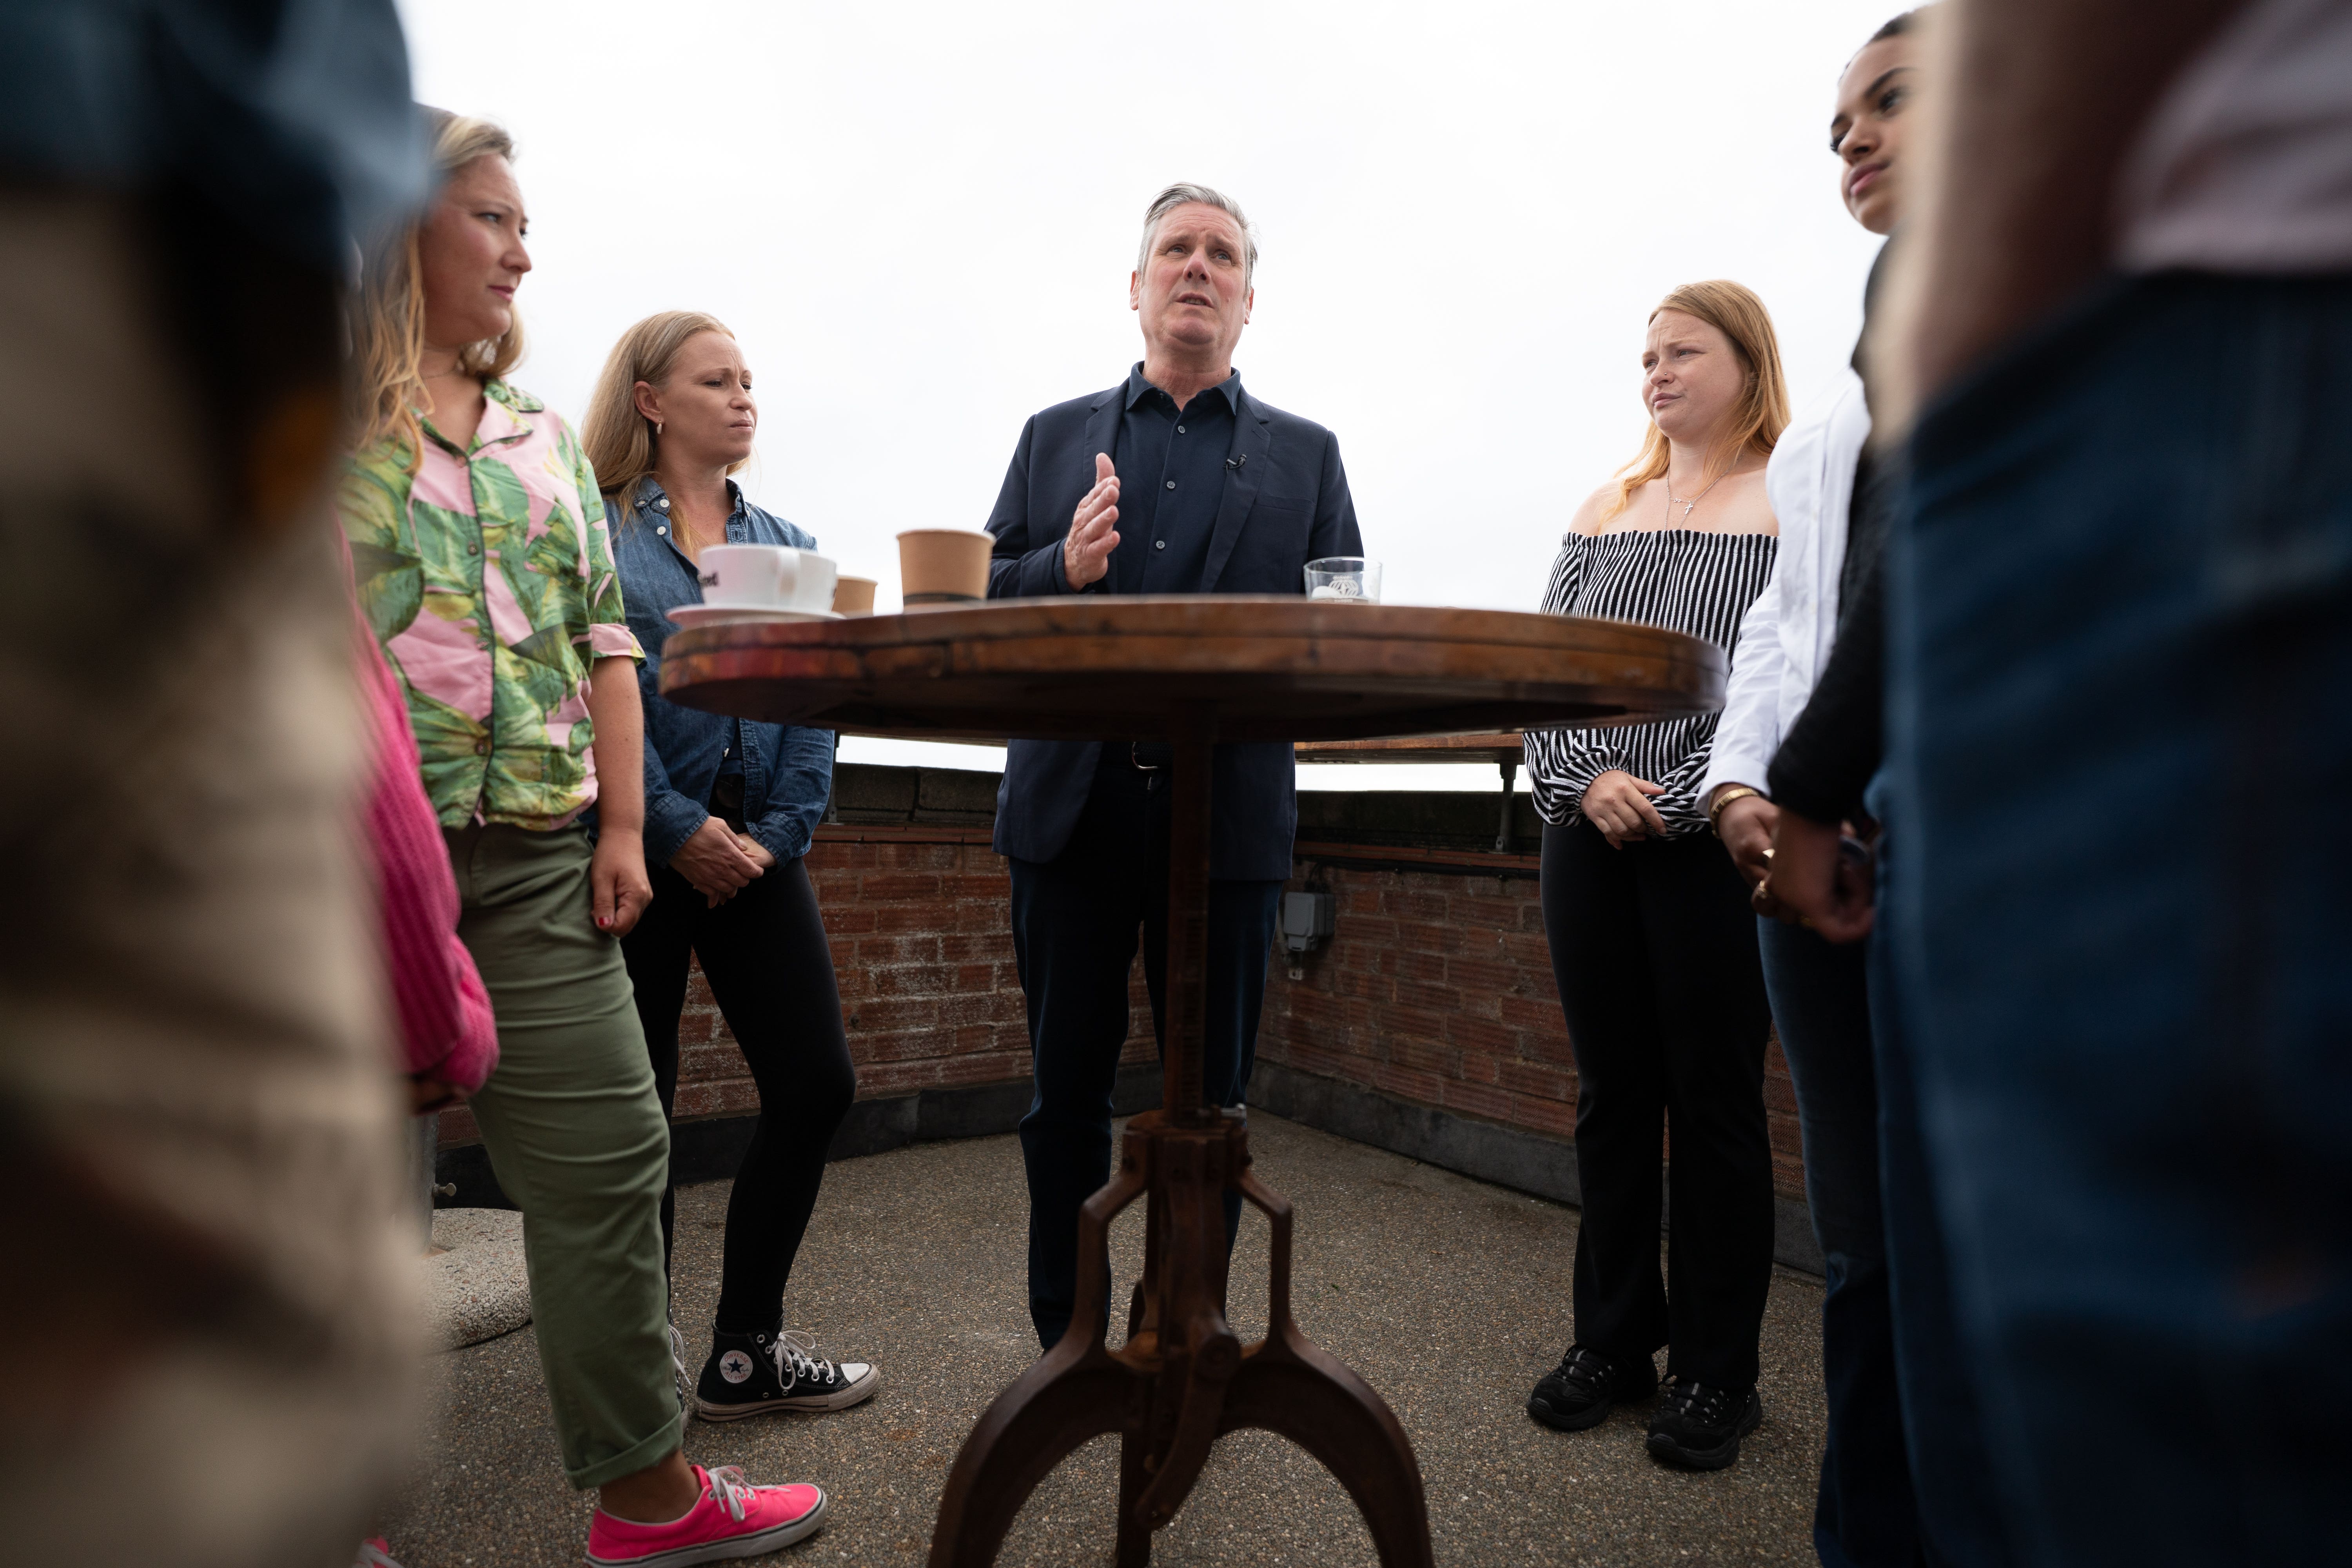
[447,825,680,1488]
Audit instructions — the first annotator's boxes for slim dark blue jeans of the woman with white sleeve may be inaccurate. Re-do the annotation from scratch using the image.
[1757,919,1919,1568]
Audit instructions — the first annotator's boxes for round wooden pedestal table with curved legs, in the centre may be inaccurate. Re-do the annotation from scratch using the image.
[661,595,1724,1568]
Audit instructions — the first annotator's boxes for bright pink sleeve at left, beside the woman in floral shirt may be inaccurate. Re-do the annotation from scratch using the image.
[353,621,499,1096]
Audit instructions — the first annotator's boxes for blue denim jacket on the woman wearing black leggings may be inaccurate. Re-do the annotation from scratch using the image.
[609,475,833,865]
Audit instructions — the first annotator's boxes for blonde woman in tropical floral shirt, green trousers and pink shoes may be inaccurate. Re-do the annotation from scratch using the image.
[341,111,826,1566]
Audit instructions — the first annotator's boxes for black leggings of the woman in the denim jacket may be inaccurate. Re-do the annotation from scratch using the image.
[621,858,858,1333]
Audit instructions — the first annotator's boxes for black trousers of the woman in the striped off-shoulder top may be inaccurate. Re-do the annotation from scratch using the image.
[1543,820,1773,1389]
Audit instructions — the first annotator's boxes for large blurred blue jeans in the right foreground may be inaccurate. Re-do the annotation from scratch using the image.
[1886,275,2352,1563]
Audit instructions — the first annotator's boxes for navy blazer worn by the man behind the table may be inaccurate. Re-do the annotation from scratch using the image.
[988,383,1364,882]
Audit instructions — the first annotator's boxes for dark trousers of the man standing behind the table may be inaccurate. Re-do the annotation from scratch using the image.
[1011,748,1282,1349]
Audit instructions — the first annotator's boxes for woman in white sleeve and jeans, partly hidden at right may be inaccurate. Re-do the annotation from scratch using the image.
[1700,12,1966,1568]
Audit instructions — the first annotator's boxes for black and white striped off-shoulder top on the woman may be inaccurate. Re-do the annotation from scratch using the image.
[1526,529,1780,835]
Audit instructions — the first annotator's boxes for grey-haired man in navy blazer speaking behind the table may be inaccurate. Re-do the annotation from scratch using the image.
[988,186,1362,1349]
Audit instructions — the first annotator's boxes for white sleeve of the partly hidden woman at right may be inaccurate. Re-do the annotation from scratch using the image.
[1698,369,1870,802]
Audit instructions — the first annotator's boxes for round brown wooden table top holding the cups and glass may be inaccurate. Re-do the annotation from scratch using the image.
[661,595,1724,740]
